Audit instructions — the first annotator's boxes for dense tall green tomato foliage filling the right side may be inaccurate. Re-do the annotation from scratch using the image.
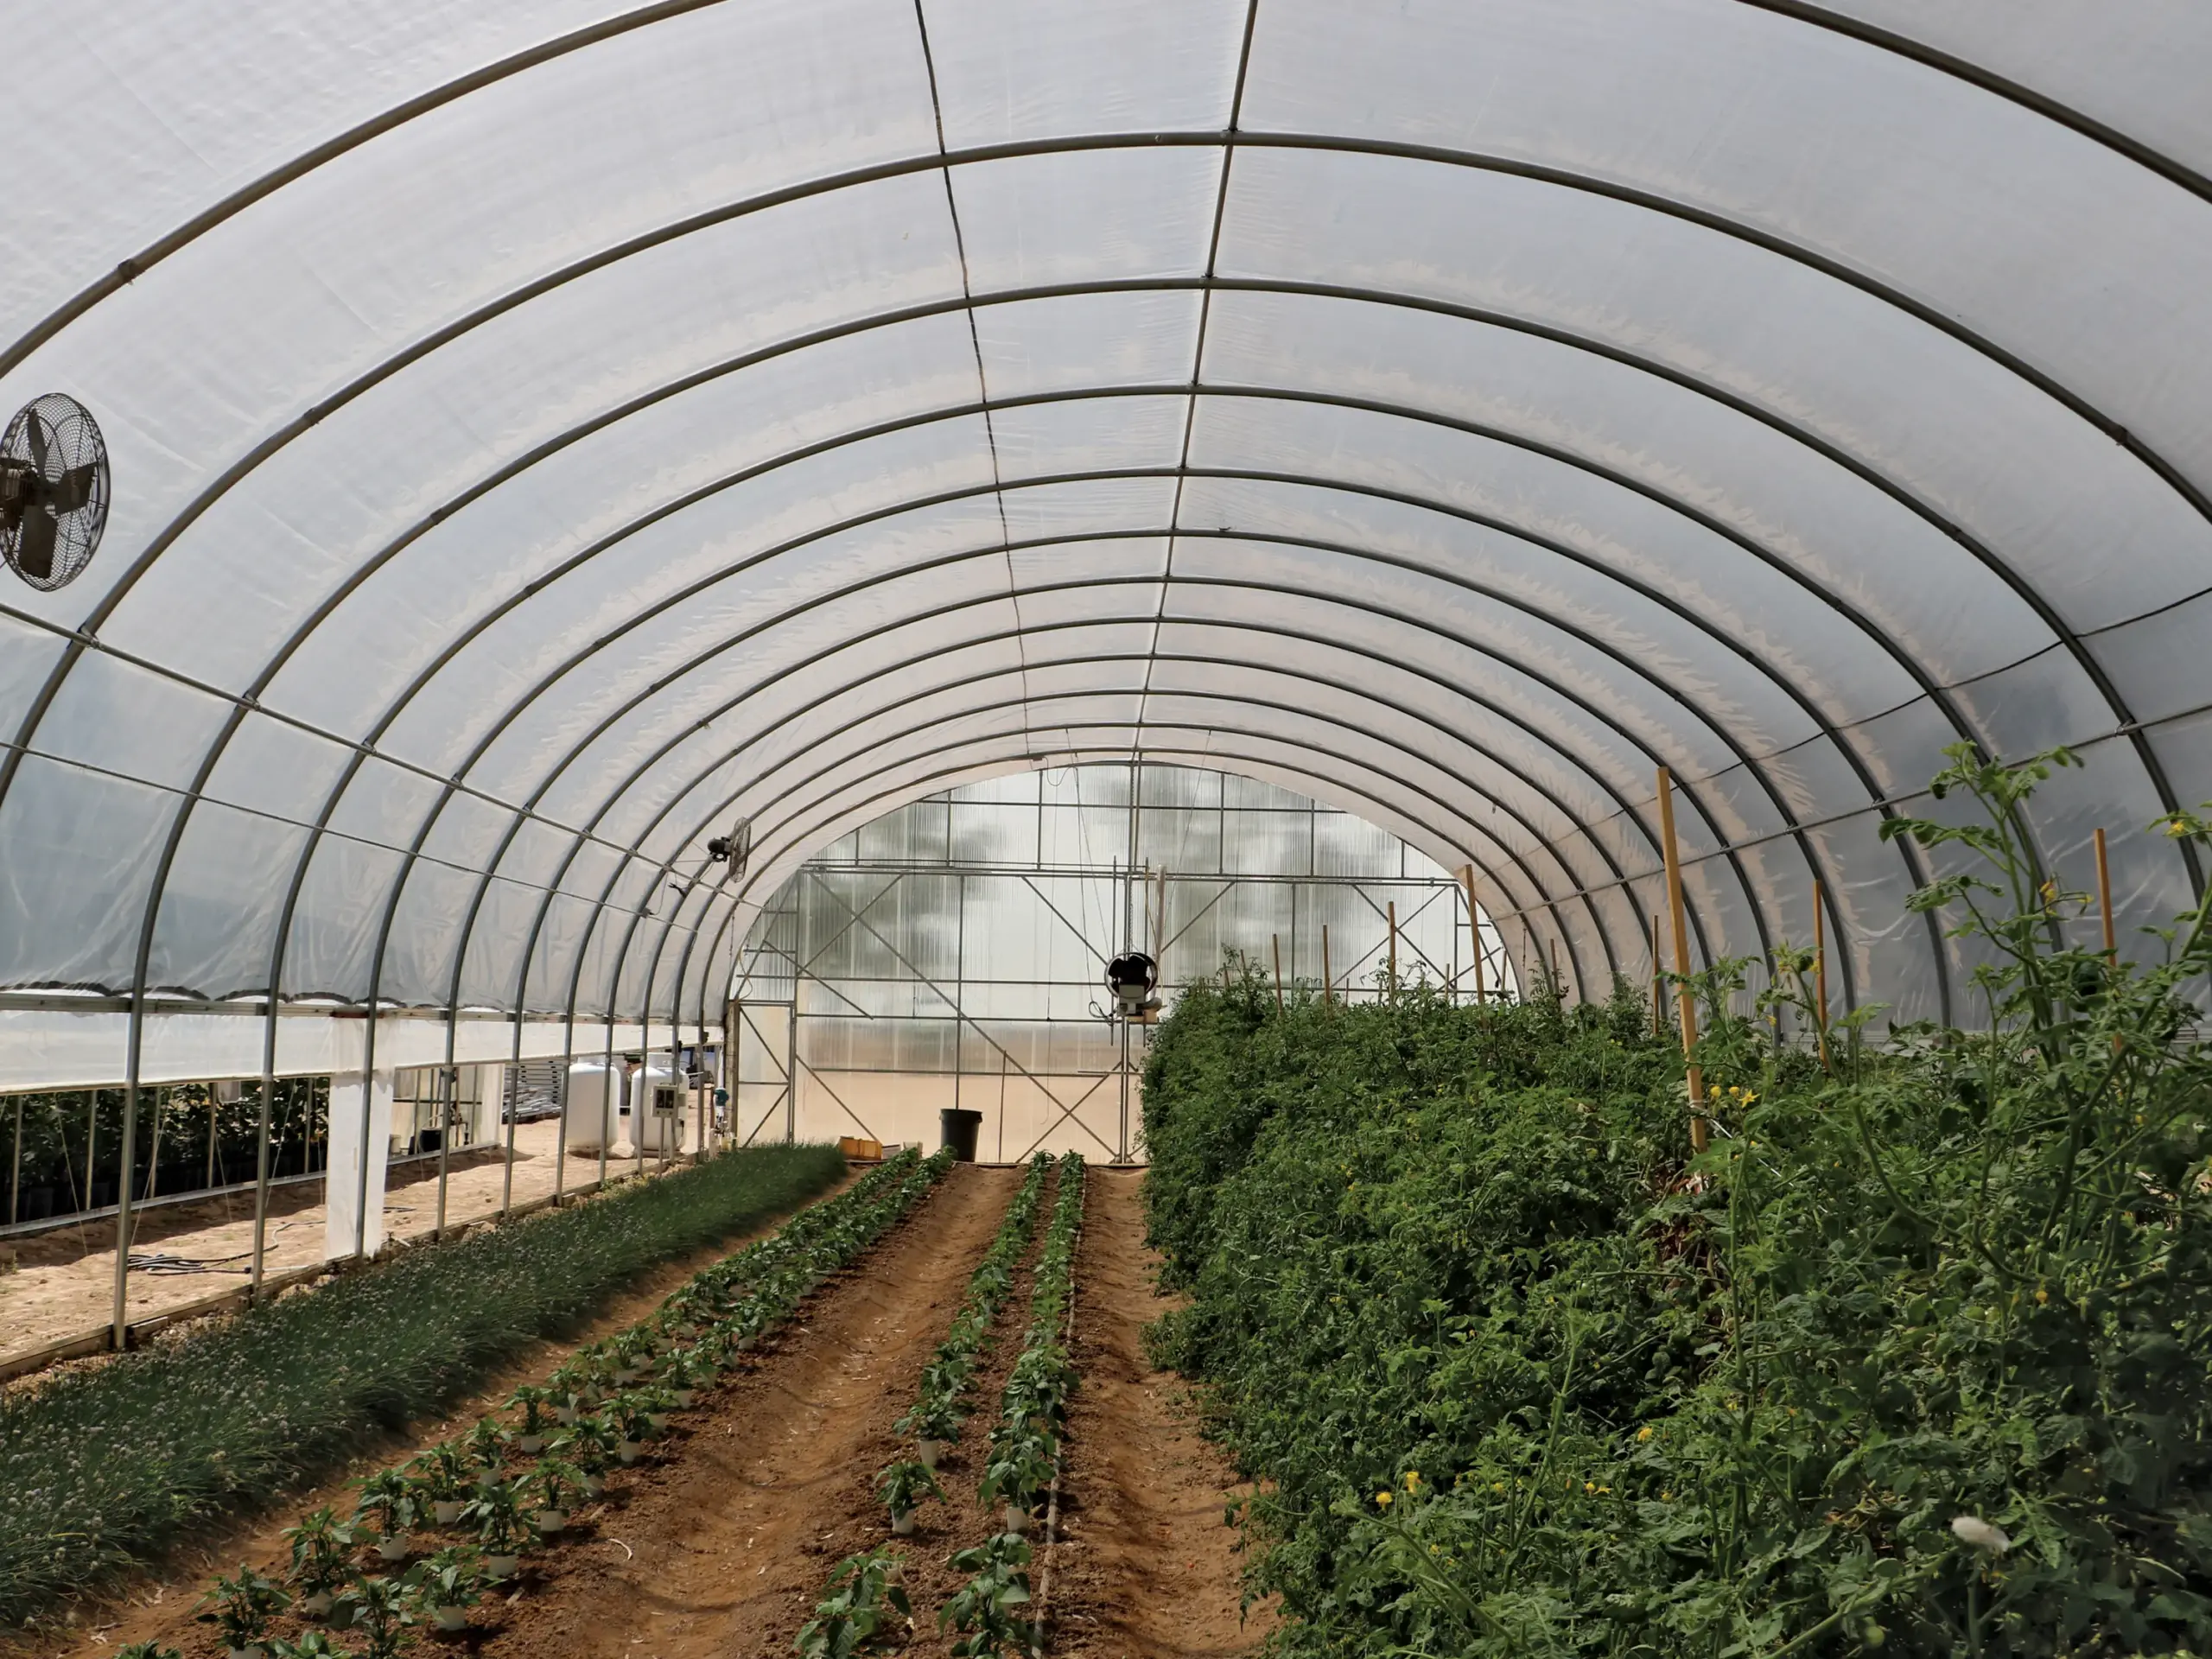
[1146,754,2212,1659]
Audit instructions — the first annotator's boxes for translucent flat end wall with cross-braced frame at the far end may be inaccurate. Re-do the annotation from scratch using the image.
[728,761,1517,1164]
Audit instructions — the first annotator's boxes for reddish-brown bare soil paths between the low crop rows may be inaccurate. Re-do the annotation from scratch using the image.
[17,1166,1269,1659]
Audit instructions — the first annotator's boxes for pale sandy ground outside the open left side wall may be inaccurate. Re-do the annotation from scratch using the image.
[0,1122,677,1363]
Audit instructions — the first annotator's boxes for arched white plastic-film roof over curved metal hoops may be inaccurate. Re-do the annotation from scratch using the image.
[0,0,2212,1071]
